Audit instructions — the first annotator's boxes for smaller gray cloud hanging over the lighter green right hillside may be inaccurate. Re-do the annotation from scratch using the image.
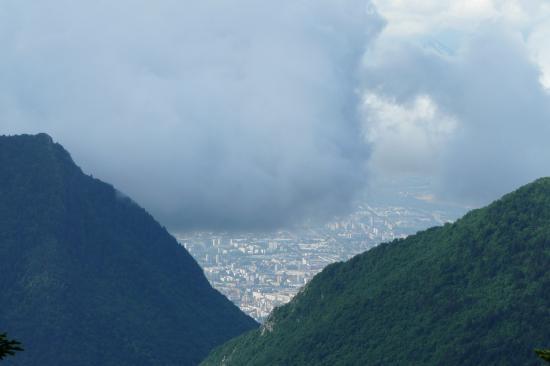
[364,22,550,205]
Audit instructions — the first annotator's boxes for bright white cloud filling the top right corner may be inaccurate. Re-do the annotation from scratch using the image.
[374,0,550,93]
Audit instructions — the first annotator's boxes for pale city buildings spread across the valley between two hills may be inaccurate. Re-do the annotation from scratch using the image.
[175,199,464,322]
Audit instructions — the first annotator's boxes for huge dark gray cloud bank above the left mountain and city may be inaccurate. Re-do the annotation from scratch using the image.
[0,0,383,228]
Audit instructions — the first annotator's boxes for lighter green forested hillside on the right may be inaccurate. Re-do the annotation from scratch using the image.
[203,178,550,366]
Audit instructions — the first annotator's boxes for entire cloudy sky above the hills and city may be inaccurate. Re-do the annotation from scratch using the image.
[0,0,550,230]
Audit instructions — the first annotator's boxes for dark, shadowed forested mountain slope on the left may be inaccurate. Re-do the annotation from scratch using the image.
[0,134,256,366]
